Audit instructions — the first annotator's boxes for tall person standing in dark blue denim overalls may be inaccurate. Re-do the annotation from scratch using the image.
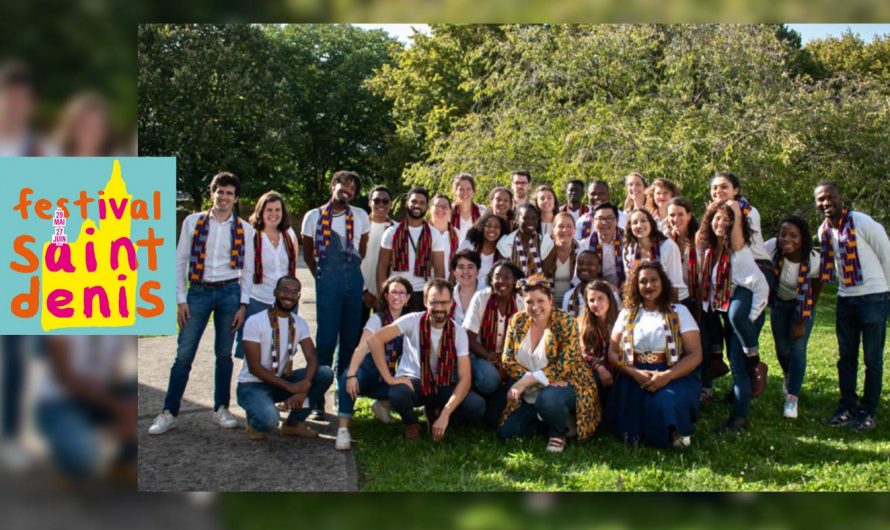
[301,171,371,419]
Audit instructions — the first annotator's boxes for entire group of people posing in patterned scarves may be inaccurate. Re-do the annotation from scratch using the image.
[149,164,890,452]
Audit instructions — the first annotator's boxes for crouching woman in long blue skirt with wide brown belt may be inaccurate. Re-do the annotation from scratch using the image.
[605,261,701,447]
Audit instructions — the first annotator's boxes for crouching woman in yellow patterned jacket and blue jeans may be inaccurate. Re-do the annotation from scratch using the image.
[498,275,601,453]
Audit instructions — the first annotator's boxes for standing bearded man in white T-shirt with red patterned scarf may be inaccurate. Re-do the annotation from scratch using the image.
[377,188,447,312]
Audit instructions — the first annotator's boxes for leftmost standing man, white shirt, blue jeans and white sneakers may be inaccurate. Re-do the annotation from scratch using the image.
[148,172,253,434]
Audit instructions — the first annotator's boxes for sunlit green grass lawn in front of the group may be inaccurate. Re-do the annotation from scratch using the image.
[351,287,890,491]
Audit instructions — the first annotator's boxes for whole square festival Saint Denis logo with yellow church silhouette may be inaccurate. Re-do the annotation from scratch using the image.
[0,157,176,335]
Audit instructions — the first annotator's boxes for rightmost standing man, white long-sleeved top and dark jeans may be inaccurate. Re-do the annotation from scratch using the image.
[814,181,890,432]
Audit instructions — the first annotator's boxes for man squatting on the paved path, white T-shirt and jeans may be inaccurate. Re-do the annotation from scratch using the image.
[237,275,334,440]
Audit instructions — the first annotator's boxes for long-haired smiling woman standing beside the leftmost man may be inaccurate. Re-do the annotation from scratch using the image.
[235,191,299,359]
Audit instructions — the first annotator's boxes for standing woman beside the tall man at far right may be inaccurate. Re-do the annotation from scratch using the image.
[765,215,822,419]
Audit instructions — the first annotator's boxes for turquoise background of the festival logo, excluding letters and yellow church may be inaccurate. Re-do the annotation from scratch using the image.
[0,157,176,335]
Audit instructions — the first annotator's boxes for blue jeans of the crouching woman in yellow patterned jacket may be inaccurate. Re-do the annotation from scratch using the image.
[498,385,575,438]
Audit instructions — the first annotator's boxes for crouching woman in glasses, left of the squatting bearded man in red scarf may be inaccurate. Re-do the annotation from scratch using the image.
[334,276,413,451]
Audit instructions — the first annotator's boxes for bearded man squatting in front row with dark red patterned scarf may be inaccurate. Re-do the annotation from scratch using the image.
[368,278,485,441]
